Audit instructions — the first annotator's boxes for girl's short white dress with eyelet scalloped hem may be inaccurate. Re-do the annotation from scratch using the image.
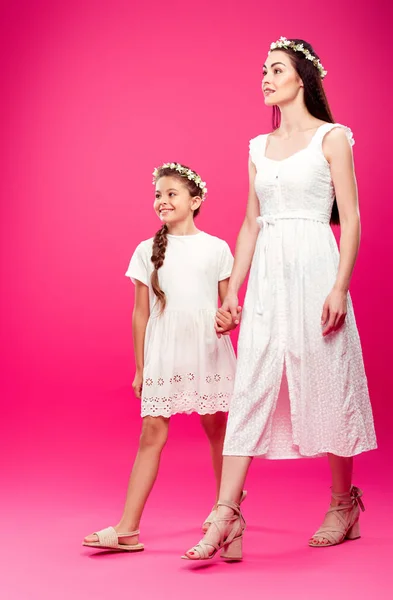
[126,232,236,417]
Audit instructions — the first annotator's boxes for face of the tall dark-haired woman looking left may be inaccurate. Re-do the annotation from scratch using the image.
[262,50,304,106]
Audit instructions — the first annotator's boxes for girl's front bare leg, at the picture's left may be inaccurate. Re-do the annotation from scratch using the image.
[85,417,169,544]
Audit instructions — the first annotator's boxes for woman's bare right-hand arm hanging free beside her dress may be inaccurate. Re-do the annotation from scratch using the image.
[322,127,360,336]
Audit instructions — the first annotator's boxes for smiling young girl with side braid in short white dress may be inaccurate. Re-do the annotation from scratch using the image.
[83,163,235,551]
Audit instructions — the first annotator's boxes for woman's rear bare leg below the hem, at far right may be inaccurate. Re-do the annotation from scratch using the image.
[311,454,353,546]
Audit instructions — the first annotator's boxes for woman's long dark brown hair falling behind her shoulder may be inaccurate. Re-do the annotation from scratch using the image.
[272,38,340,225]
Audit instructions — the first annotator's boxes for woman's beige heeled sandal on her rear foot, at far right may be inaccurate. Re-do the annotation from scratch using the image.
[308,486,365,548]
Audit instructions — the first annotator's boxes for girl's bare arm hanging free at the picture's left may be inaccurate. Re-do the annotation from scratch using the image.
[132,280,150,398]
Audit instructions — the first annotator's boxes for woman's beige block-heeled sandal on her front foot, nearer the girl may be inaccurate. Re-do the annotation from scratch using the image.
[182,502,246,560]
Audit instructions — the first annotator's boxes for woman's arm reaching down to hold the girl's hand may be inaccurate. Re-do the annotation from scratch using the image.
[222,158,260,323]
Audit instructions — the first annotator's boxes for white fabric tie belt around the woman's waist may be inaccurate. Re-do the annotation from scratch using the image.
[256,211,330,315]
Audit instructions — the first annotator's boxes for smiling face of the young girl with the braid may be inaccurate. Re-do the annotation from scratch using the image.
[154,176,202,224]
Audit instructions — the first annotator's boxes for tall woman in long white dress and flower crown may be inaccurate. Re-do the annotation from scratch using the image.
[184,38,376,560]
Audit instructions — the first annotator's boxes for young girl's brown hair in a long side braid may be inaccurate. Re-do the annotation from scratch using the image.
[150,163,203,313]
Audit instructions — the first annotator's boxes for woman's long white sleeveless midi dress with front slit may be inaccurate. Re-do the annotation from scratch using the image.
[224,124,376,458]
